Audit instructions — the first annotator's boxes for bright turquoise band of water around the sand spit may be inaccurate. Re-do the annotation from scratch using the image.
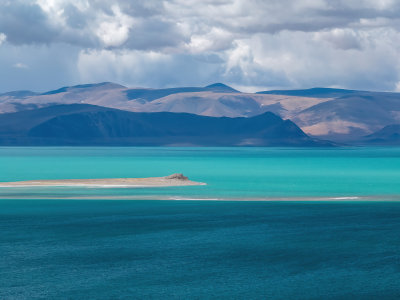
[0,147,400,199]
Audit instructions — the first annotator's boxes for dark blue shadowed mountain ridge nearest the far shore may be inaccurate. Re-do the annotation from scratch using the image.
[0,104,332,146]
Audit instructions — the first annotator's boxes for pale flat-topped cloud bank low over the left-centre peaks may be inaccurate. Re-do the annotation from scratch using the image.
[77,49,221,87]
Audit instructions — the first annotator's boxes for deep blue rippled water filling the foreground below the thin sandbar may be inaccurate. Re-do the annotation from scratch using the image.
[0,200,400,299]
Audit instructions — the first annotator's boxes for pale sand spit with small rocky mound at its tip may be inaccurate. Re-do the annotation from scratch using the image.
[0,174,205,187]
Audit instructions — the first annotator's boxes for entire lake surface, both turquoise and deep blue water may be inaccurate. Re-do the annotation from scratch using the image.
[0,147,400,299]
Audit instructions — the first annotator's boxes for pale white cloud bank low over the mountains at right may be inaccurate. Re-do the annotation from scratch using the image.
[233,30,400,90]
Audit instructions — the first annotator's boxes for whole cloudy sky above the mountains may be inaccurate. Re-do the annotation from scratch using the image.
[0,0,400,92]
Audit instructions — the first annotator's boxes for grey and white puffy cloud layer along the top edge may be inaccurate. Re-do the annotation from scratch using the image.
[0,0,400,52]
